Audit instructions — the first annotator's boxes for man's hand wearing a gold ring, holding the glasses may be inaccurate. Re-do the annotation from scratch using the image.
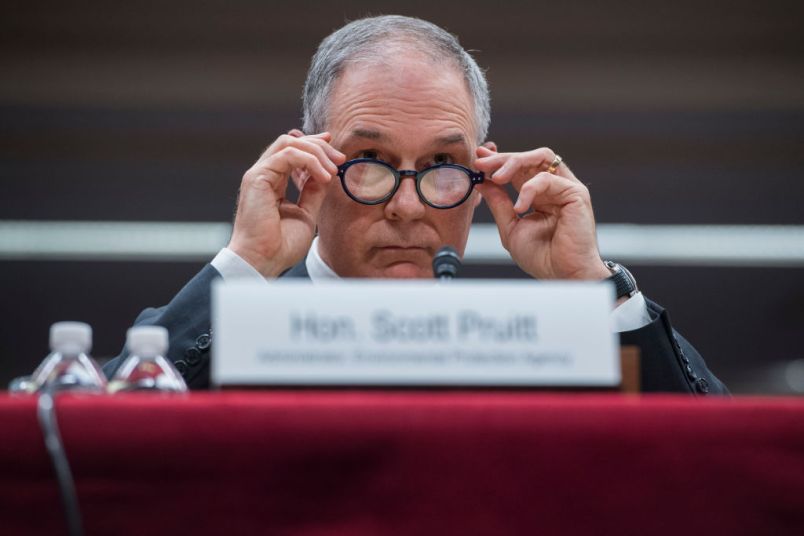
[475,147,611,279]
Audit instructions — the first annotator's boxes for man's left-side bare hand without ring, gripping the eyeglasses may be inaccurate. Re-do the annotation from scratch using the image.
[228,131,346,277]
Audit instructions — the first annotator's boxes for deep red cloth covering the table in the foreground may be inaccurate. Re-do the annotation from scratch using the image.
[0,391,804,535]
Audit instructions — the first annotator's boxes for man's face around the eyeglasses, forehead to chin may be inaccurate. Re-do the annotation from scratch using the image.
[318,55,480,278]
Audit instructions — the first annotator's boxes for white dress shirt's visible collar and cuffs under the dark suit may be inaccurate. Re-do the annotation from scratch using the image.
[211,236,651,333]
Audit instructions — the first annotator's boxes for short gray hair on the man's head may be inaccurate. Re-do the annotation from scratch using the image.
[302,15,491,144]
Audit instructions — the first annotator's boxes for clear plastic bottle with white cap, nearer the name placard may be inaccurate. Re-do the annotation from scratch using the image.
[109,326,187,393]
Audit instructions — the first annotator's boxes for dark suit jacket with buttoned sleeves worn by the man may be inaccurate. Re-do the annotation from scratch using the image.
[103,262,728,394]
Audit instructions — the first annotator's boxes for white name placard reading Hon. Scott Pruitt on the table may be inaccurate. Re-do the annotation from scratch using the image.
[211,280,620,386]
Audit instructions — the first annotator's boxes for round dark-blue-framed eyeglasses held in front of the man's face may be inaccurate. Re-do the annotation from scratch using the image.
[338,158,483,209]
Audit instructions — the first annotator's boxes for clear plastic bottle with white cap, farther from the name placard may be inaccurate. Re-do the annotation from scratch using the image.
[25,322,106,393]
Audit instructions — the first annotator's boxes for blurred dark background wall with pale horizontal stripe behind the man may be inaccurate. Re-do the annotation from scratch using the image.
[0,0,804,394]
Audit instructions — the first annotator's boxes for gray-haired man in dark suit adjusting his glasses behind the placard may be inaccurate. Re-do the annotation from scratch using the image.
[106,16,726,394]
